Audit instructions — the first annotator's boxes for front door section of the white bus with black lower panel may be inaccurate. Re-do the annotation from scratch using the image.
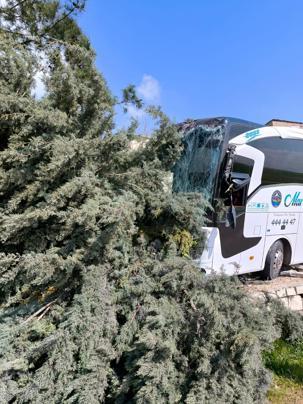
[220,145,267,273]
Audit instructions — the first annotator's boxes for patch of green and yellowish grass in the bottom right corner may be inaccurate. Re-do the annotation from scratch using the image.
[264,340,303,404]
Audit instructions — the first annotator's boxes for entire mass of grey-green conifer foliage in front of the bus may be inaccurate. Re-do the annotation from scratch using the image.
[0,0,302,404]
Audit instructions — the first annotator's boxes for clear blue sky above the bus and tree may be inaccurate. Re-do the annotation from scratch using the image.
[78,0,303,129]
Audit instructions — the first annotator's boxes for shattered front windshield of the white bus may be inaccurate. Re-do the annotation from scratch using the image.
[173,125,224,200]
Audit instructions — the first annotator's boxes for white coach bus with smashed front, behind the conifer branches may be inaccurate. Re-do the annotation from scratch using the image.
[173,117,303,279]
